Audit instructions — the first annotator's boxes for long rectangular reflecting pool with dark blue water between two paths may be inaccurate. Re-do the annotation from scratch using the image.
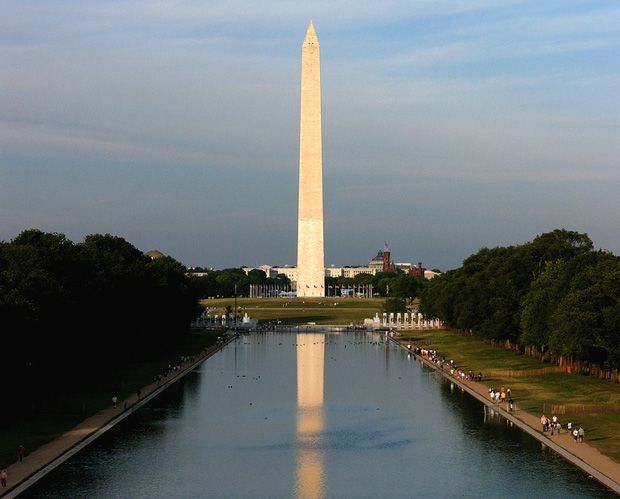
[23,332,615,498]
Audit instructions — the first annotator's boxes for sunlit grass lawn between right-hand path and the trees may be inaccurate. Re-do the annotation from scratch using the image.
[399,331,620,462]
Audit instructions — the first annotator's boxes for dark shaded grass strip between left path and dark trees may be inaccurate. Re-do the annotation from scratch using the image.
[0,332,221,468]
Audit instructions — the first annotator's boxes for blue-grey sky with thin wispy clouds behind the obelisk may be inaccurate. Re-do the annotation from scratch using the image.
[0,0,620,269]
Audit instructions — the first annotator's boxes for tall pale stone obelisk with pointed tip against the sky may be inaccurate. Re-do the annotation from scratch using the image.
[297,21,325,296]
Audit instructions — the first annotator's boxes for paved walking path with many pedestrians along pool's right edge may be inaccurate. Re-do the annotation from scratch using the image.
[390,338,620,494]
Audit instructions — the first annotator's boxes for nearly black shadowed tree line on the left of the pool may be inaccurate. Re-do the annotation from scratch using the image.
[0,230,200,418]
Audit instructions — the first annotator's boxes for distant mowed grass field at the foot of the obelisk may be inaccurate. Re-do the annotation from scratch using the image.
[201,297,384,325]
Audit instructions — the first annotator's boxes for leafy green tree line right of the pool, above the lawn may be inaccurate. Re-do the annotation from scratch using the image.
[421,229,620,368]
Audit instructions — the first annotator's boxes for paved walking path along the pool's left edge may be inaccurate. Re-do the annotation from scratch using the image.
[0,334,235,499]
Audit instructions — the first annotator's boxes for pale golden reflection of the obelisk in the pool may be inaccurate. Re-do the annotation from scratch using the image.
[296,333,325,499]
